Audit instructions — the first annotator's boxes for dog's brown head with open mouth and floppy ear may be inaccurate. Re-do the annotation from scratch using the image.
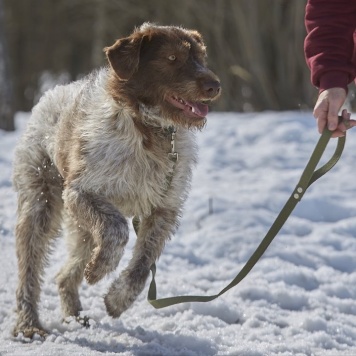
[105,23,221,127]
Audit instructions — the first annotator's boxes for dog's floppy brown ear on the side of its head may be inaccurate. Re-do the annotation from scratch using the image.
[104,36,143,80]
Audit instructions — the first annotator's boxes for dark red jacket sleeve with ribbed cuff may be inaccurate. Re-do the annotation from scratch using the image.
[304,0,356,91]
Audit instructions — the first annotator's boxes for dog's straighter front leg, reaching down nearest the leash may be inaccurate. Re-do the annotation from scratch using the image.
[105,208,178,318]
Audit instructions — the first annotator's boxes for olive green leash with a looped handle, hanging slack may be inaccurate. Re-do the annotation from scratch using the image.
[140,121,346,309]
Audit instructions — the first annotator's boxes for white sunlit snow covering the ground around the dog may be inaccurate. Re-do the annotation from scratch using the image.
[0,112,356,356]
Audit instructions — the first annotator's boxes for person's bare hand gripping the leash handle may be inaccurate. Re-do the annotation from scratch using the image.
[313,88,356,137]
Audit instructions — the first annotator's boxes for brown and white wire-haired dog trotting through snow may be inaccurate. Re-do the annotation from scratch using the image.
[13,23,221,338]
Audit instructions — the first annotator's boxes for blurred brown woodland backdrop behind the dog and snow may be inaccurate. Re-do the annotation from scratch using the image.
[0,0,348,130]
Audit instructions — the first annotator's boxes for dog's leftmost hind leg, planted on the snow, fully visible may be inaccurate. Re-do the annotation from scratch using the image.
[13,151,63,337]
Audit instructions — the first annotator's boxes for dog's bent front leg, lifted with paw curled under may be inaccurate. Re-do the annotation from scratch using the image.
[63,186,129,284]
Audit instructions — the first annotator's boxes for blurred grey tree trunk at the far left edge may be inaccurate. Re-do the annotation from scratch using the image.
[0,0,15,131]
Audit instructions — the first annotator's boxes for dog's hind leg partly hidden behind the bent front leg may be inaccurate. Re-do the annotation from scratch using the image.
[57,217,93,318]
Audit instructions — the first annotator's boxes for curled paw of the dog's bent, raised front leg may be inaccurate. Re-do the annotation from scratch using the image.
[84,246,124,284]
